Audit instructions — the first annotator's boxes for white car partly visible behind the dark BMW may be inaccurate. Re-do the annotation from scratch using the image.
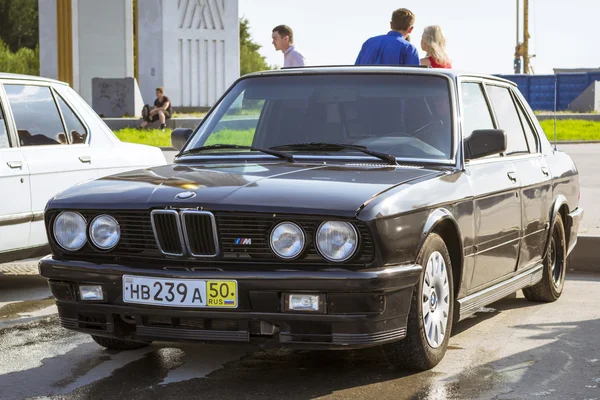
[0,73,167,263]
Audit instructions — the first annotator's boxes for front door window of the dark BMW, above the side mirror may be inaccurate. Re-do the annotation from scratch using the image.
[461,83,494,137]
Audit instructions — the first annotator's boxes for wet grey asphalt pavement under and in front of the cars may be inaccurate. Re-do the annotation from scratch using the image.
[0,275,600,400]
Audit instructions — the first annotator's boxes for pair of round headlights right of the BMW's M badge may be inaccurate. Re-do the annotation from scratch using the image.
[269,221,358,262]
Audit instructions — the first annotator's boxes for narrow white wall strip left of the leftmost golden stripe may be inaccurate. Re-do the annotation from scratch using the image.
[38,0,58,79]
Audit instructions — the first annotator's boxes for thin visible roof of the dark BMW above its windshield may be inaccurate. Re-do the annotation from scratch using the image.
[240,65,516,86]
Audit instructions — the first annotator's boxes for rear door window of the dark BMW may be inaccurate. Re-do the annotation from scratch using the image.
[487,86,529,155]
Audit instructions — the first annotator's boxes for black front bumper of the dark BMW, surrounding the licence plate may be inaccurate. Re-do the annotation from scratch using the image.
[39,257,422,348]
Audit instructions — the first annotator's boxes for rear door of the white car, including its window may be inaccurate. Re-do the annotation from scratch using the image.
[4,82,96,246]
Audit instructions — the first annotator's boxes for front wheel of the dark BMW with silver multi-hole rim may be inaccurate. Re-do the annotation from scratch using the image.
[383,233,454,371]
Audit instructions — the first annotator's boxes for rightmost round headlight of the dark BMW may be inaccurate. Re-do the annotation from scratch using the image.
[317,221,358,262]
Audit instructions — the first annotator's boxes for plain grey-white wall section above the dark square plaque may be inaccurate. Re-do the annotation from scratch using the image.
[77,0,133,104]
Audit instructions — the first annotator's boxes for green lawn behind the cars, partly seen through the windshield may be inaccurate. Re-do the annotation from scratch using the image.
[115,119,600,147]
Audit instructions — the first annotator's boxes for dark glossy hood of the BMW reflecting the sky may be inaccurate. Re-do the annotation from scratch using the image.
[49,163,443,216]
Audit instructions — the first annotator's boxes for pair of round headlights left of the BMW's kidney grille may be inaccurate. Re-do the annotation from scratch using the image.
[54,211,121,251]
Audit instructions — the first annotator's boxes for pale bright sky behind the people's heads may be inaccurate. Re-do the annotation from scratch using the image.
[239,0,600,74]
